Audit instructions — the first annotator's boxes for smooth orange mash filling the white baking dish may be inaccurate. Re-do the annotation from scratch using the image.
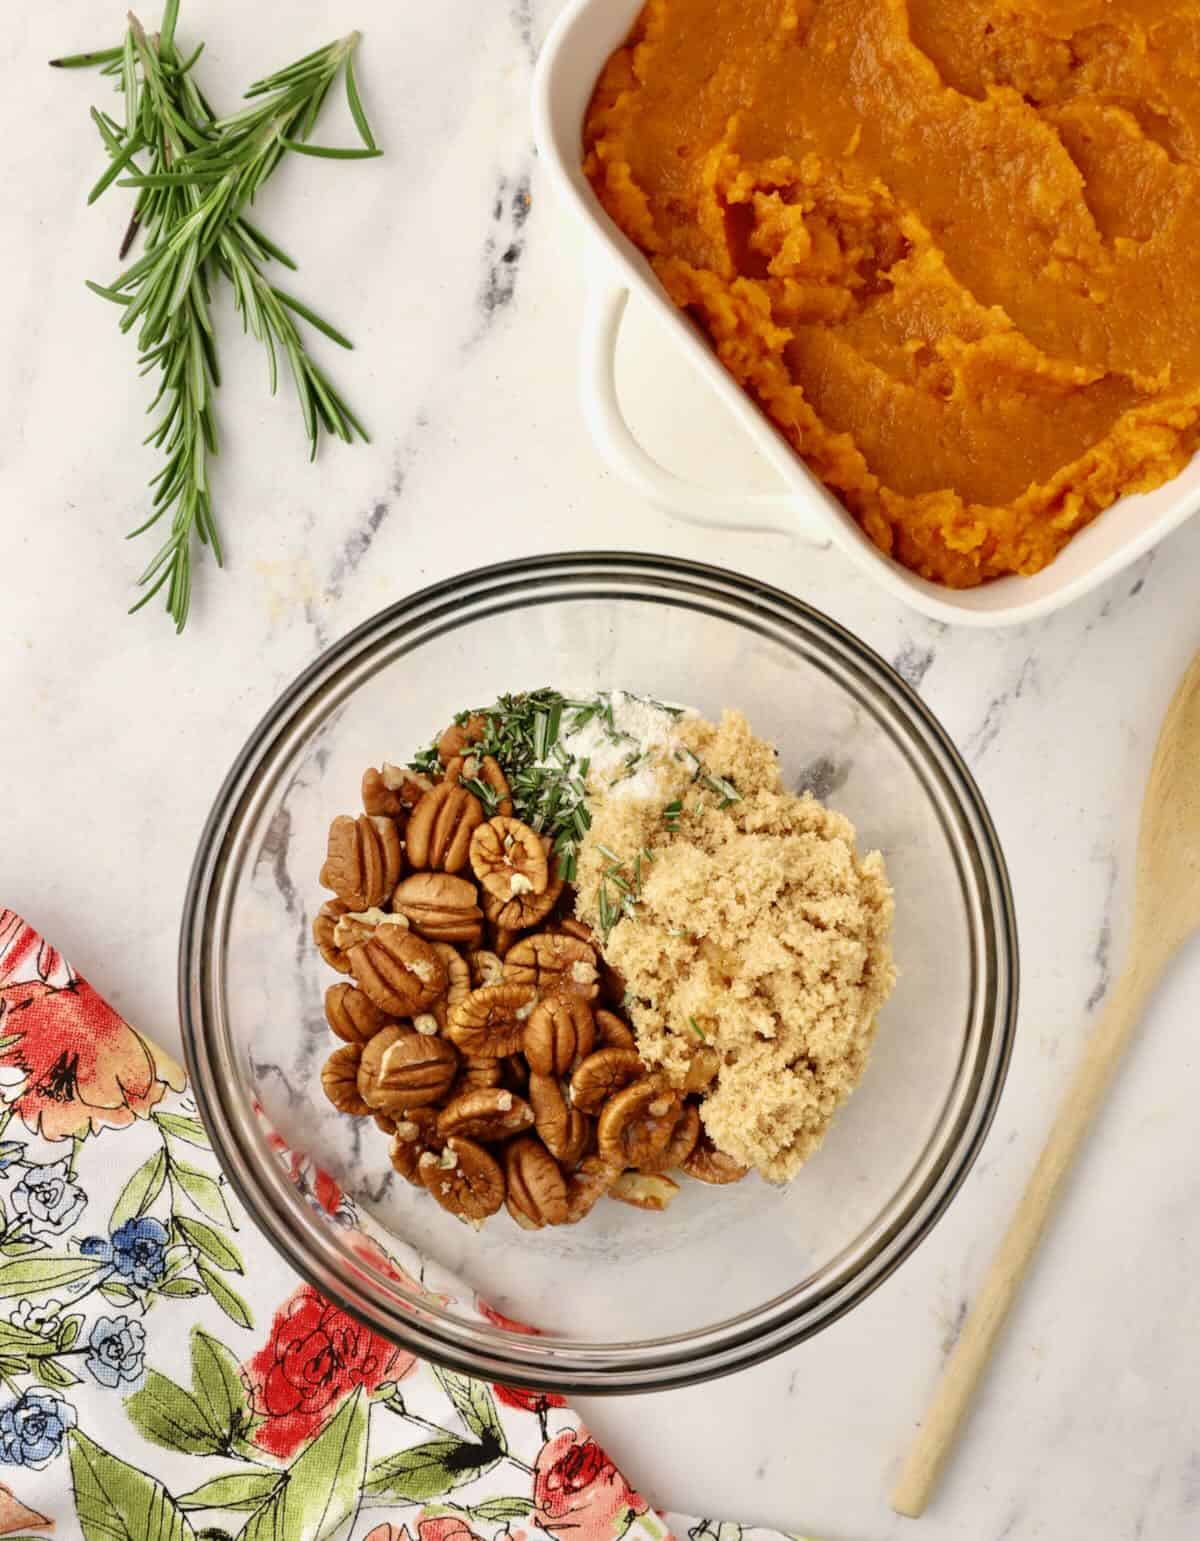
[584,0,1200,587]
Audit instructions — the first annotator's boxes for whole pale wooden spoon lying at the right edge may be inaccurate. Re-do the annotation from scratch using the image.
[892,658,1200,1518]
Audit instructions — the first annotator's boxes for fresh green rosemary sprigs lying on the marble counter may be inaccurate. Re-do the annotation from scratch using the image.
[51,0,380,632]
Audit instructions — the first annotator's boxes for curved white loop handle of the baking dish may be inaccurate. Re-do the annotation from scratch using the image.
[581,271,829,546]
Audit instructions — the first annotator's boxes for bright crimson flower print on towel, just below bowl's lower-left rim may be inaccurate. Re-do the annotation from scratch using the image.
[242,1284,416,1459]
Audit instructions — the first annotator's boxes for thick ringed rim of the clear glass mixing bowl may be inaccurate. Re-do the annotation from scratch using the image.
[179,552,1018,1395]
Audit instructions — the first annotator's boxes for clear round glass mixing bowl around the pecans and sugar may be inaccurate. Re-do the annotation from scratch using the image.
[180,553,1017,1393]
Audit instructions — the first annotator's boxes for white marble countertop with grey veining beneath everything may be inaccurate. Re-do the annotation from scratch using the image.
[0,0,1200,1541]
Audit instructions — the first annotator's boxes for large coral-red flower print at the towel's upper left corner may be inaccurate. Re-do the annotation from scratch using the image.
[0,973,186,1140]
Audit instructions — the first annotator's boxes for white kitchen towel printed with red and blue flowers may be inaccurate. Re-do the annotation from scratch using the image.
[0,909,813,1541]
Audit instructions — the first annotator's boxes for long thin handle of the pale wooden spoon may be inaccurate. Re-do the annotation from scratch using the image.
[892,963,1157,1519]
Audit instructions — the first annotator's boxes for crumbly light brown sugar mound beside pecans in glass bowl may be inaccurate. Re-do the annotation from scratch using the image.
[578,712,895,1182]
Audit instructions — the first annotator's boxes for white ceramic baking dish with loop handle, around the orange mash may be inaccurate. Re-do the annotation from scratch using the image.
[533,0,1200,626]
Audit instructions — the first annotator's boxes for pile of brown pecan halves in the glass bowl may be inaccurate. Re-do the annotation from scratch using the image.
[313,720,746,1230]
